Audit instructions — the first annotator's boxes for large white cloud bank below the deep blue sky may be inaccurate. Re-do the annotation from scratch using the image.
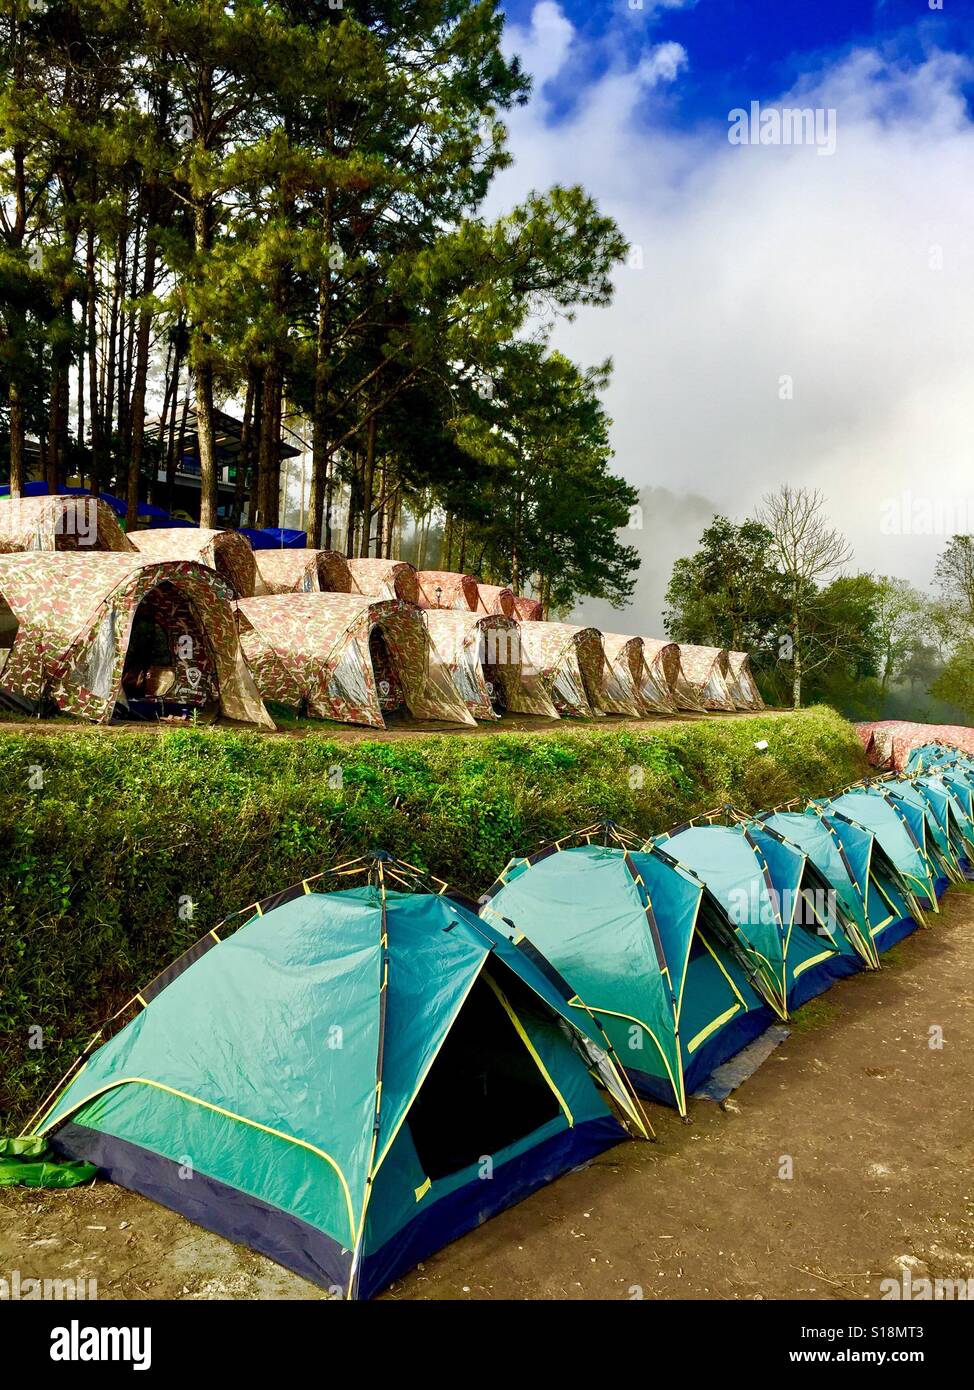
[492,0,974,626]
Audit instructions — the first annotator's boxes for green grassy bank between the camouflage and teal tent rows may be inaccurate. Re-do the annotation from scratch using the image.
[0,709,864,1133]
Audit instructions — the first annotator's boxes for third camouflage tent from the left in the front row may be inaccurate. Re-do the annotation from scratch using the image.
[425,609,519,719]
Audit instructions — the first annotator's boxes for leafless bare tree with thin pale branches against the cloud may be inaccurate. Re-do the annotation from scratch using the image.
[760,482,852,709]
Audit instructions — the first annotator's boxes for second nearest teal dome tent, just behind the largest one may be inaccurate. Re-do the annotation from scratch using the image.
[481,827,773,1115]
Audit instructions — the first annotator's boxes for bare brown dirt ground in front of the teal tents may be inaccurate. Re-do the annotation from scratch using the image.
[0,890,974,1300]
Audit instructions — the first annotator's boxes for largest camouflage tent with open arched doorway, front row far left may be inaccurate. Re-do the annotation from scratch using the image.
[0,553,274,728]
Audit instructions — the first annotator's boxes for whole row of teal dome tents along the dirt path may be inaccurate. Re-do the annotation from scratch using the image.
[17,748,974,1297]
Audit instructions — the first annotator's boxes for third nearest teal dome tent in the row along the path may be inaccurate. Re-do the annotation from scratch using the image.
[654,821,859,1019]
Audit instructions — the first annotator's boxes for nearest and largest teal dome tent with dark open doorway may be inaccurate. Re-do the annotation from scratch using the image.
[35,856,646,1298]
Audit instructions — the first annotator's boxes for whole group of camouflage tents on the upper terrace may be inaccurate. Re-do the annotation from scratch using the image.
[0,496,763,728]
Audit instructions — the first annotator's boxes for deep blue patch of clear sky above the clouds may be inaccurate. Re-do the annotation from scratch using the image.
[504,0,974,125]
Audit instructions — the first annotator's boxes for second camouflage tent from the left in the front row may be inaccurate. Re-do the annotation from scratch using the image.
[236,594,474,728]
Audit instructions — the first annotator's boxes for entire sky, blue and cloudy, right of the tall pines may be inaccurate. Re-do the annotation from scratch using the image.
[497,0,974,631]
